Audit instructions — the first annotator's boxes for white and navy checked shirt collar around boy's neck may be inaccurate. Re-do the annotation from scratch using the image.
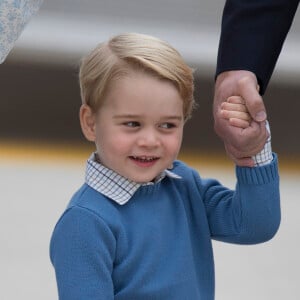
[85,153,181,205]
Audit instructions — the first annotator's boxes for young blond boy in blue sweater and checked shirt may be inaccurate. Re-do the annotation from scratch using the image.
[50,34,280,300]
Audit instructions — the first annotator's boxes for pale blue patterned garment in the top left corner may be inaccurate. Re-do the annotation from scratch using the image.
[0,0,43,63]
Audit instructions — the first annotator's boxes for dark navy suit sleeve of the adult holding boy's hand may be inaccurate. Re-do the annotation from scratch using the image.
[216,0,299,94]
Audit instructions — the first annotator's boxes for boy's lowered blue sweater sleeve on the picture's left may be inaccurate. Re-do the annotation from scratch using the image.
[50,207,116,300]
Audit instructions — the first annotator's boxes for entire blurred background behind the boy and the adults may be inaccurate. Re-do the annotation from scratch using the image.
[0,0,300,300]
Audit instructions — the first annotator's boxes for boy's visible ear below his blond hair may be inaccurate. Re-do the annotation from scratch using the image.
[79,104,96,142]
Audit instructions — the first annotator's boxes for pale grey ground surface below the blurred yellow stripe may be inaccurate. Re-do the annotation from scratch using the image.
[0,157,300,300]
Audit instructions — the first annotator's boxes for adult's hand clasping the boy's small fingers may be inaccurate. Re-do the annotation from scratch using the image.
[213,70,268,166]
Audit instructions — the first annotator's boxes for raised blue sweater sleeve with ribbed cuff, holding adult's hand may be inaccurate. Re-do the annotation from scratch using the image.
[203,154,280,244]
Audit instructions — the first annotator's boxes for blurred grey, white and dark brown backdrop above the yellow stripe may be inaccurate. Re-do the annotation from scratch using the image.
[0,0,300,157]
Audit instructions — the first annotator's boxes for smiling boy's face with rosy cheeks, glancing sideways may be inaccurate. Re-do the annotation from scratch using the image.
[88,73,184,182]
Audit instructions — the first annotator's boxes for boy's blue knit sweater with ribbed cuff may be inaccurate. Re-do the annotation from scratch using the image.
[50,155,280,300]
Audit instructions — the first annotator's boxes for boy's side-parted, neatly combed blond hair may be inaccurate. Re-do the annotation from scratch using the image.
[79,33,194,119]
